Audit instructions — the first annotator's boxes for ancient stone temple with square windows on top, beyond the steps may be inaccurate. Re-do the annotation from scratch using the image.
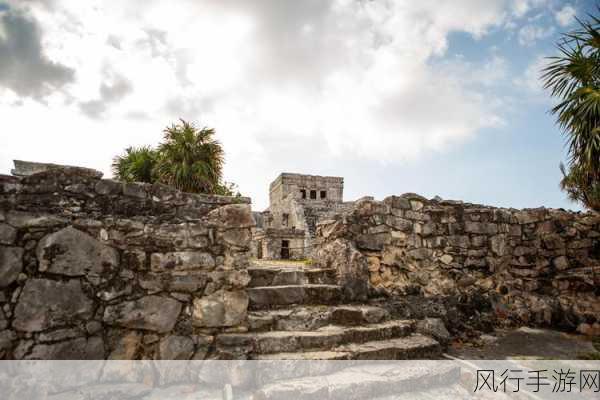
[252,173,353,260]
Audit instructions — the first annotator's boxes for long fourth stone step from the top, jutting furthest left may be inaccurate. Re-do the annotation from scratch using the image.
[216,320,415,355]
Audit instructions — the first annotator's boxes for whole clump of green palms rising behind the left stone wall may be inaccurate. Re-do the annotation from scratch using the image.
[112,120,240,196]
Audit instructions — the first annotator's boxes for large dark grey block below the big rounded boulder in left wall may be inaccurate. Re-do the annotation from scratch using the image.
[13,279,94,332]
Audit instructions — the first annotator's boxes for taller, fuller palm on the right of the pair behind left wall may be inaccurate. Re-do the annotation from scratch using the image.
[156,120,224,193]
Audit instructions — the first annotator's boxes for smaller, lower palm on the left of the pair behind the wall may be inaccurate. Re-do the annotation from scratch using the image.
[112,146,158,183]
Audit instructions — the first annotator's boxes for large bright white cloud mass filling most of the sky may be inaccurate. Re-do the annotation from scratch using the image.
[0,0,556,208]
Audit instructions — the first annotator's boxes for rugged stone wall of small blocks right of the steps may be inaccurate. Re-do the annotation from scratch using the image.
[315,194,600,334]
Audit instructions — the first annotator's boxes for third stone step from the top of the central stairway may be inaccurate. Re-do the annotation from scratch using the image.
[248,305,389,332]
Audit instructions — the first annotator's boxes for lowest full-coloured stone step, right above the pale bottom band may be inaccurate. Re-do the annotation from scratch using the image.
[257,333,442,360]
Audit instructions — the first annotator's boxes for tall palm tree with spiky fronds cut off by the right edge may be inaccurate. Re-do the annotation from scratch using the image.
[542,11,600,211]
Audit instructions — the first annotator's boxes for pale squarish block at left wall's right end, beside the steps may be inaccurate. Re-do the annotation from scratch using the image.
[192,290,249,327]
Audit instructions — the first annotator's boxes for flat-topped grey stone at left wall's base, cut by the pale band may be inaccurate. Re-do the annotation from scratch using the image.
[25,336,104,360]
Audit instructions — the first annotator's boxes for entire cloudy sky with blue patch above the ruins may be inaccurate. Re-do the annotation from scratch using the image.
[0,0,597,210]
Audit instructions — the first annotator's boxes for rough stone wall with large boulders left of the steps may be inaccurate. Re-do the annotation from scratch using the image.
[0,162,254,359]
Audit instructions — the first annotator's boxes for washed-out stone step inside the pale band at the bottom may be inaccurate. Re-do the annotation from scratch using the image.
[253,363,454,400]
